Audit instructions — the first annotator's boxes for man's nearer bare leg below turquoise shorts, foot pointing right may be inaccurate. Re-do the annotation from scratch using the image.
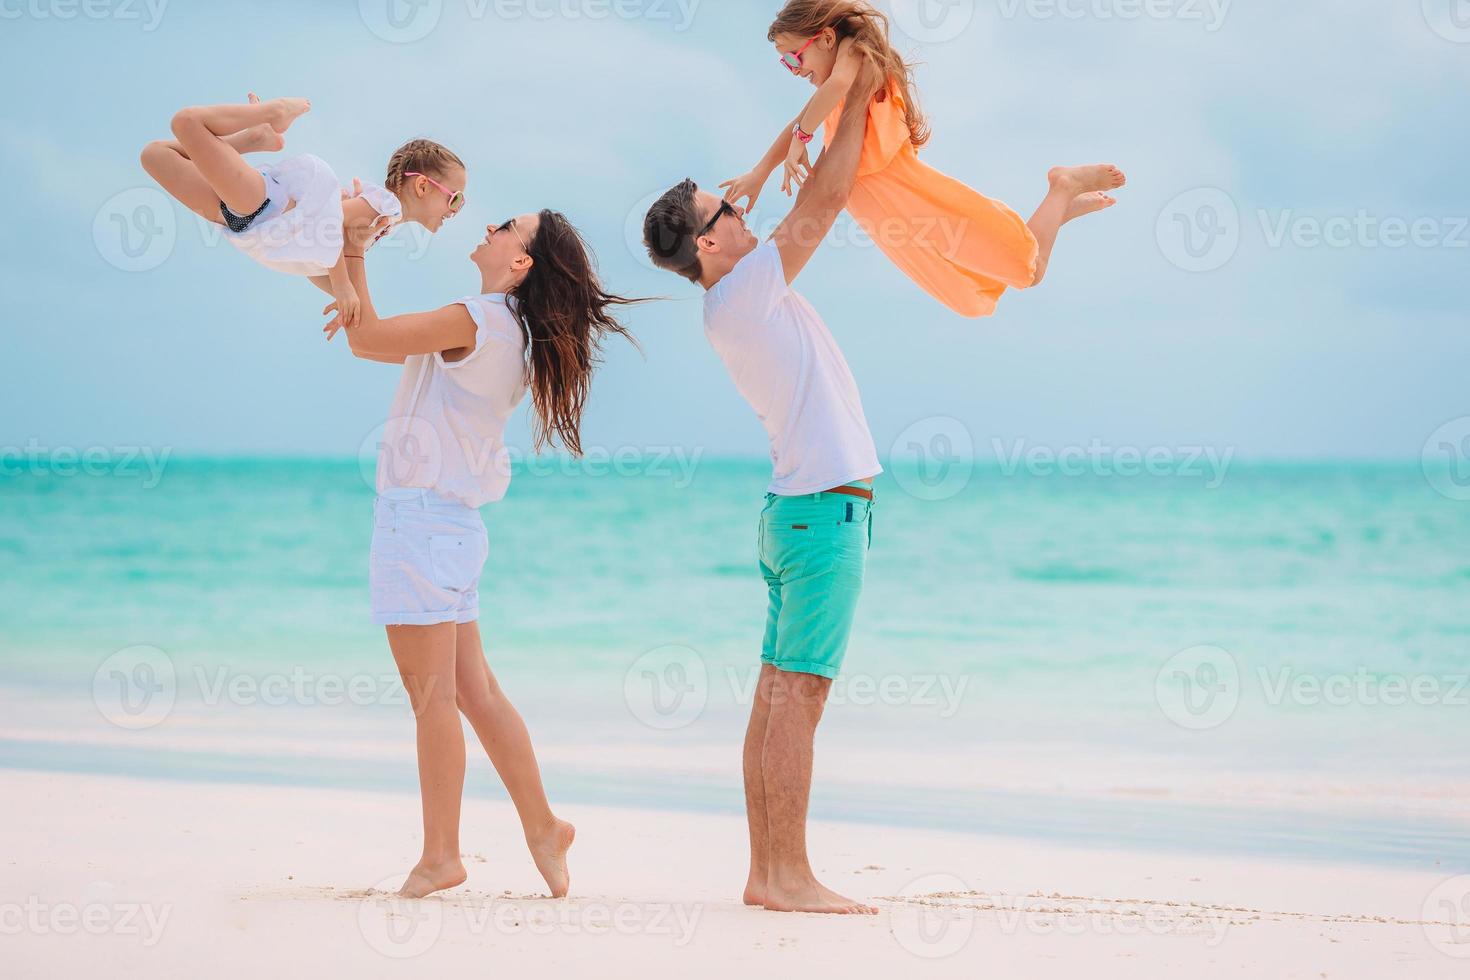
[761,670,878,915]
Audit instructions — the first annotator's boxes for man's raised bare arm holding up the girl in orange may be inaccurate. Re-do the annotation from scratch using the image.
[770,60,882,284]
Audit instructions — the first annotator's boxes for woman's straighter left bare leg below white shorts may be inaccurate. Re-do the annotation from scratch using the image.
[388,623,466,898]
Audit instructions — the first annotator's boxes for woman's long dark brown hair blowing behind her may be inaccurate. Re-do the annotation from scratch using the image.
[515,210,644,455]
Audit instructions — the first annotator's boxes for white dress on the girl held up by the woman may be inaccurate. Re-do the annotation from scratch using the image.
[225,153,403,276]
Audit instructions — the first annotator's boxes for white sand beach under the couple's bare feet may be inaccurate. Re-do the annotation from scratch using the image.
[0,770,1470,979]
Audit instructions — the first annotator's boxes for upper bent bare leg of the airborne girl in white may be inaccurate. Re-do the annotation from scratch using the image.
[173,98,312,215]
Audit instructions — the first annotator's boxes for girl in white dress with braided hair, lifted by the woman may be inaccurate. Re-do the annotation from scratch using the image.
[143,94,466,326]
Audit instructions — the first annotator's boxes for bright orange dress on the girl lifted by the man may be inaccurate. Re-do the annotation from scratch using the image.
[826,81,1036,316]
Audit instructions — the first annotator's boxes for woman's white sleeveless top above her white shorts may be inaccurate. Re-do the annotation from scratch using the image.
[378,292,528,507]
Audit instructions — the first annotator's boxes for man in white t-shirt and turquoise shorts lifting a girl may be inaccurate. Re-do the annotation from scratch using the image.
[644,65,882,914]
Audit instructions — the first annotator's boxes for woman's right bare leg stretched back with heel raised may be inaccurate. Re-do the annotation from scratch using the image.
[454,623,576,898]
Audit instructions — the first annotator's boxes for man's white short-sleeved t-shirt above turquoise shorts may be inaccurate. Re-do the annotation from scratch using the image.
[704,241,882,497]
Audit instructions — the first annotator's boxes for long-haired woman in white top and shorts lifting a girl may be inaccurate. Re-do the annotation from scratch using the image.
[326,210,632,898]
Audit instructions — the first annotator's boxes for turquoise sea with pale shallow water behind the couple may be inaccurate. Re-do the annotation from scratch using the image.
[0,454,1470,870]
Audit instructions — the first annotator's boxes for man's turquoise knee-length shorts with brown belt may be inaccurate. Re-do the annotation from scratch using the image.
[760,485,873,677]
